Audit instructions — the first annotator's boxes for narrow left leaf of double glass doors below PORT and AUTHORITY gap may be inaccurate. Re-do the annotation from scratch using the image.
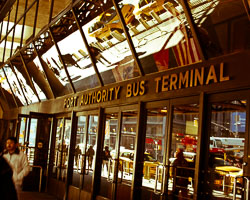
[72,116,87,187]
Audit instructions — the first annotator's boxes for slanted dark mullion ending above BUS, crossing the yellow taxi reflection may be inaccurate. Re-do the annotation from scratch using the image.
[112,0,145,76]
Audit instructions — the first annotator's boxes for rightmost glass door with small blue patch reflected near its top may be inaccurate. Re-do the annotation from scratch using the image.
[202,94,249,199]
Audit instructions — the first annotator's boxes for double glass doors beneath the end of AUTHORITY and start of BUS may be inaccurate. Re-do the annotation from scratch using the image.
[99,106,138,200]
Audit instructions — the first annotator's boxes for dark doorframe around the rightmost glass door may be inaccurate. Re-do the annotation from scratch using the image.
[195,89,250,199]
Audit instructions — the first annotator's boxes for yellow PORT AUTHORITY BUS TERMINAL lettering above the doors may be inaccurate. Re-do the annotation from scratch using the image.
[64,63,230,108]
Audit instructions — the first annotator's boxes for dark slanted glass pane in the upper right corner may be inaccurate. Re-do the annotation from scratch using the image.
[189,0,250,57]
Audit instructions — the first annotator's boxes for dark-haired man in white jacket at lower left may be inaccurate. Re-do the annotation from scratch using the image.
[3,137,30,193]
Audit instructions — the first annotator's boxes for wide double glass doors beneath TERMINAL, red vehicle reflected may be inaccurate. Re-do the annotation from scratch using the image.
[140,97,199,200]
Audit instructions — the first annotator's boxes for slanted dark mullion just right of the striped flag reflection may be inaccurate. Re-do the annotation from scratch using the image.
[179,0,206,61]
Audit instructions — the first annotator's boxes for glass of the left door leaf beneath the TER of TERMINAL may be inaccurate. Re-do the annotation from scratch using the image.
[142,107,167,190]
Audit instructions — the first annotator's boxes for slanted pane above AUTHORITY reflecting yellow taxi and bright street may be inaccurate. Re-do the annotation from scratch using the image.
[83,4,139,84]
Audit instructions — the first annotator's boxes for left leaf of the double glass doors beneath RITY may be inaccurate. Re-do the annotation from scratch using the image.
[100,113,119,199]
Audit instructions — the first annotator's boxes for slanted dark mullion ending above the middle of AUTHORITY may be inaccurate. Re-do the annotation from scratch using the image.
[72,8,104,86]
